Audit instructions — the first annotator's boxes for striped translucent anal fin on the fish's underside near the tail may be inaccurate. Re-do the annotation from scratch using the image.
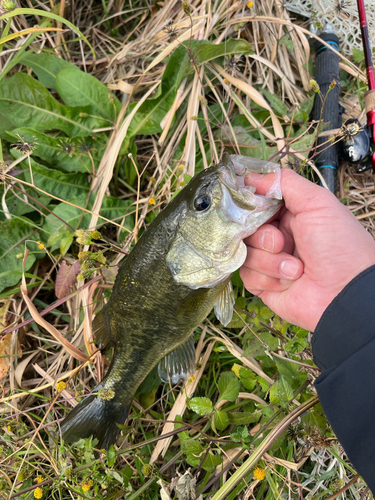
[158,335,195,385]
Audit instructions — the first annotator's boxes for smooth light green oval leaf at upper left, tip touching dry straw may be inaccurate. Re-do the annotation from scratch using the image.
[56,68,121,122]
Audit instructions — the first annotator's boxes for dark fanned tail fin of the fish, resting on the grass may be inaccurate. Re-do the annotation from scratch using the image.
[61,394,131,450]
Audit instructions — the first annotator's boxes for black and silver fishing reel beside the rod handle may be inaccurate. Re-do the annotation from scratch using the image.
[338,118,372,172]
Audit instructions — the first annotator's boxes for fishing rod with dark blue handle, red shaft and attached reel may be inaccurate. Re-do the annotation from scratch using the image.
[312,0,375,193]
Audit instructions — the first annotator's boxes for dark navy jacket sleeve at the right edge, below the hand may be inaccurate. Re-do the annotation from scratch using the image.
[312,266,375,493]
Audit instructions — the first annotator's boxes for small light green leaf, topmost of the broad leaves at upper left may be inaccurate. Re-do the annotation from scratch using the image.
[21,50,78,90]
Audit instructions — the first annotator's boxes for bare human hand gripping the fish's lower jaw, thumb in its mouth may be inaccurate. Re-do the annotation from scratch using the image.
[240,169,375,331]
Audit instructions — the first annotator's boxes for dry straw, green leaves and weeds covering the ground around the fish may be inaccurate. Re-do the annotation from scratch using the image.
[0,0,375,500]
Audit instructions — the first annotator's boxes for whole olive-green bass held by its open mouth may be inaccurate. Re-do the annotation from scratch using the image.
[61,154,283,449]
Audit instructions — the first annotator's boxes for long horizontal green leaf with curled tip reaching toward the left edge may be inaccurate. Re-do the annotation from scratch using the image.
[5,128,106,173]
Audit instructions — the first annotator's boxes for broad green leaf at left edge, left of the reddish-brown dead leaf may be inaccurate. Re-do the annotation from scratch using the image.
[0,219,40,291]
